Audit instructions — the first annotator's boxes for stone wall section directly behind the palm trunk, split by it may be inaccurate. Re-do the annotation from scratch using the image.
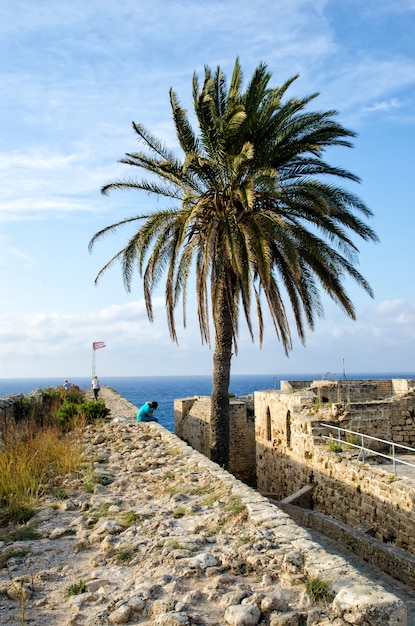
[174,396,256,486]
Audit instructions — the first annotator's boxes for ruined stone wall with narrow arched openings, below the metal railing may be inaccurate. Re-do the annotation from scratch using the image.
[255,392,415,555]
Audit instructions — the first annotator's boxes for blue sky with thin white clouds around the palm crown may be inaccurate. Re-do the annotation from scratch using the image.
[0,0,415,379]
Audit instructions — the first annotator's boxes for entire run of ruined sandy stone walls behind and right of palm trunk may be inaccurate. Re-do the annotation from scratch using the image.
[175,380,415,564]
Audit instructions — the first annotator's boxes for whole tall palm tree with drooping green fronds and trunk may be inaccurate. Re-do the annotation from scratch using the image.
[89,59,377,467]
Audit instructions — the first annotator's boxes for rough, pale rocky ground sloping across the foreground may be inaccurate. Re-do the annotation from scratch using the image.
[0,388,406,626]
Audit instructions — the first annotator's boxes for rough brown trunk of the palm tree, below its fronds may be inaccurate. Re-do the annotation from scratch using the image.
[210,289,232,469]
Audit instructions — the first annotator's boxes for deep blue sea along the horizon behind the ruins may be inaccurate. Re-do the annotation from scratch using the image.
[0,372,415,432]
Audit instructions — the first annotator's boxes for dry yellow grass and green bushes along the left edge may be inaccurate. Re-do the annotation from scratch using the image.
[0,389,109,520]
